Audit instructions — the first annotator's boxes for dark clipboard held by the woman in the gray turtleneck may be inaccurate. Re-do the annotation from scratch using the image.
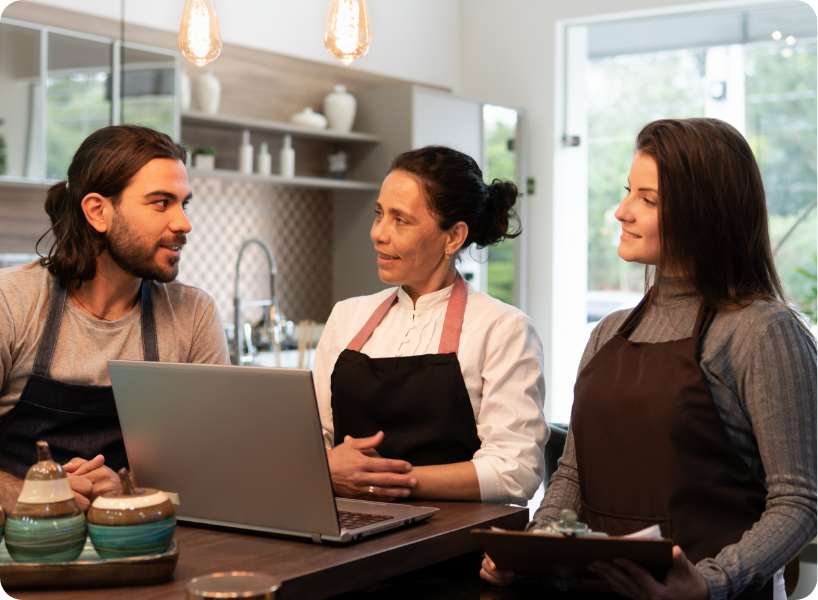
[471,529,673,581]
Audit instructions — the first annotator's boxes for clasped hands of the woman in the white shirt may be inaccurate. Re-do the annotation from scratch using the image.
[327,431,418,502]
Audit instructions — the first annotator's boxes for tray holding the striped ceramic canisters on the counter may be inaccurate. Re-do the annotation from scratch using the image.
[0,538,179,590]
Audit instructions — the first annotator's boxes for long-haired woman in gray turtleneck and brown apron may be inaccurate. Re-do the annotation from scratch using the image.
[481,119,818,600]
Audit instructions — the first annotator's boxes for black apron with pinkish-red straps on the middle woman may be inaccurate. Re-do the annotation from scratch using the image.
[331,273,480,466]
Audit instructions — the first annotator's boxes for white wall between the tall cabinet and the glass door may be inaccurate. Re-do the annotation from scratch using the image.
[456,0,728,416]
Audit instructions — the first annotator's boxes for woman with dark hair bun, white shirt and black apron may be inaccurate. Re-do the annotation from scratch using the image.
[314,146,548,503]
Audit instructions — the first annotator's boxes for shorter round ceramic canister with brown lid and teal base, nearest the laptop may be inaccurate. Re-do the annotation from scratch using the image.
[88,469,176,558]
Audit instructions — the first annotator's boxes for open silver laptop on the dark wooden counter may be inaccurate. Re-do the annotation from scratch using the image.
[108,360,438,543]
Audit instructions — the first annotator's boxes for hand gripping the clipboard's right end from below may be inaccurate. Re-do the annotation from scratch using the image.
[588,546,710,600]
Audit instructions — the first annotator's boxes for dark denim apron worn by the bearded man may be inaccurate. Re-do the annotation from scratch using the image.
[0,278,159,477]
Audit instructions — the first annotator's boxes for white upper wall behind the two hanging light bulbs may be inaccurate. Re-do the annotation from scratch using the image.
[17,0,460,88]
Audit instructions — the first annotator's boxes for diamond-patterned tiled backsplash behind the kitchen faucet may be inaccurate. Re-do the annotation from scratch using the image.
[179,175,332,323]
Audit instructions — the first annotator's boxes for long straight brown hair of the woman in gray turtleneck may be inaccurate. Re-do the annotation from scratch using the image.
[636,119,787,310]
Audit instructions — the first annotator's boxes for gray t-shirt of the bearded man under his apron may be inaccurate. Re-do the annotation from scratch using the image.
[0,261,228,418]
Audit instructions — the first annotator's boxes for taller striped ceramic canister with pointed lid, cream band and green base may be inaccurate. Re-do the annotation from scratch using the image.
[5,442,86,562]
